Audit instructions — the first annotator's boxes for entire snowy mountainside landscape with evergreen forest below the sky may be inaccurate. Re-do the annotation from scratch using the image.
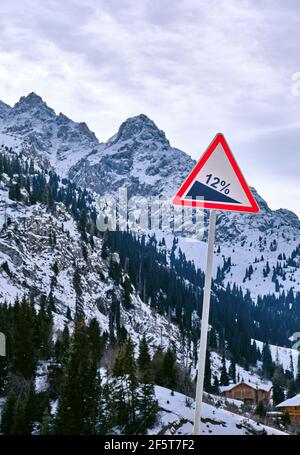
[0,93,300,434]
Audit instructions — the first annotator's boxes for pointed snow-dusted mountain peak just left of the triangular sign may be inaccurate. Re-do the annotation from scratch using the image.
[69,114,194,196]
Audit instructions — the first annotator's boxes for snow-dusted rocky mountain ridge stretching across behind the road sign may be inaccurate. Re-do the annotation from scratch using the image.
[0,93,300,296]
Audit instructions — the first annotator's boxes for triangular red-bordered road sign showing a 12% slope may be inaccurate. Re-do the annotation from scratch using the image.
[173,133,259,213]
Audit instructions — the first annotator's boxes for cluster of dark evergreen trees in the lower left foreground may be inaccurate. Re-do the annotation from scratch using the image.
[0,296,159,435]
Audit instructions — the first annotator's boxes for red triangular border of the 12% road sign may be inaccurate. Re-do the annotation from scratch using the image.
[172,133,259,213]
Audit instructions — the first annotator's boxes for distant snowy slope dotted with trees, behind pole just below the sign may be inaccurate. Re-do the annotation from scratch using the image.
[155,212,300,300]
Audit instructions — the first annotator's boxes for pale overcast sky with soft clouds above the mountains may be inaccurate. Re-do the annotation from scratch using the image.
[0,0,300,215]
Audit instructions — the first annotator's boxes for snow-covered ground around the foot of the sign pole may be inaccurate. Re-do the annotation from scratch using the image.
[154,386,285,435]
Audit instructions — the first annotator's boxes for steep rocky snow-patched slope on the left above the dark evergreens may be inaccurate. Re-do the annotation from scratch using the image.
[0,182,191,363]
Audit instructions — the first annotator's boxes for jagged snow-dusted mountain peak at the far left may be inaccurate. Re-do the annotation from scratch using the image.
[0,92,100,176]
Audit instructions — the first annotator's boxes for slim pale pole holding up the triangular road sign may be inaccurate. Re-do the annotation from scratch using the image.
[194,210,216,435]
